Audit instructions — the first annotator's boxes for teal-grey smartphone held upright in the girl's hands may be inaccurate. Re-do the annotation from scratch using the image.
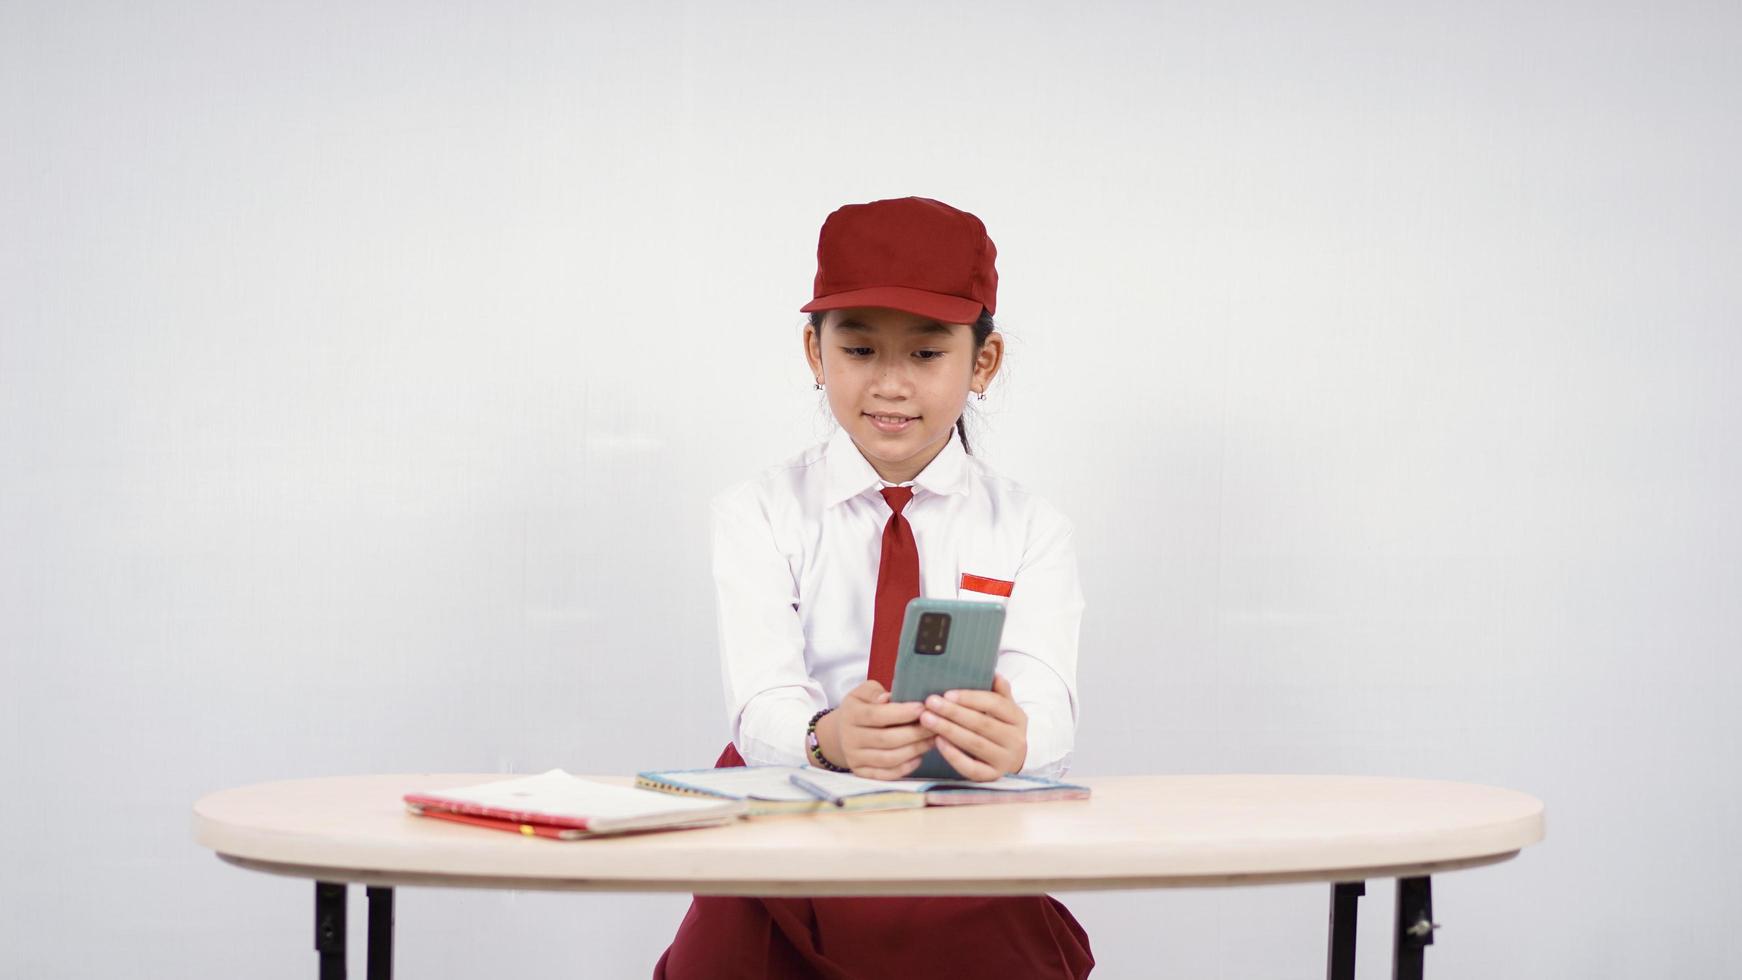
[888,597,1003,780]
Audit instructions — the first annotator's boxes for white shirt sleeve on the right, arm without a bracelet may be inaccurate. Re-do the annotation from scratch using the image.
[998,507,1084,780]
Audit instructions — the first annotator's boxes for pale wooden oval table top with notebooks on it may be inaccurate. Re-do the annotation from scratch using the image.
[193,773,1543,895]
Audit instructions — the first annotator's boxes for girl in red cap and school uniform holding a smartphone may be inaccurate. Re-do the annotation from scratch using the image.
[653,197,1094,980]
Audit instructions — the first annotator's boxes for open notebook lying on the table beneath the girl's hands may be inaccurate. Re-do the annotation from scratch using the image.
[636,766,1089,816]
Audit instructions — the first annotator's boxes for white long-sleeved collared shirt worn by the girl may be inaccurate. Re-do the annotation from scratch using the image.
[712,430,1084,778]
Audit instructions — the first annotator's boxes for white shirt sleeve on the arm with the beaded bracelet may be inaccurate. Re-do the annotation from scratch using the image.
[712,484,827,766]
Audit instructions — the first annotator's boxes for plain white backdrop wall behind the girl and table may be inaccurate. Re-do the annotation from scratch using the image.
[0,0,1742,980]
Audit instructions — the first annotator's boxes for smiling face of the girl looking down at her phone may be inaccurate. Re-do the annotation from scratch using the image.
[805,306,1003,484]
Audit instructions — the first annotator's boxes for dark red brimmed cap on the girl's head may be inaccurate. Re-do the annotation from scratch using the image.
[798,197,998,324]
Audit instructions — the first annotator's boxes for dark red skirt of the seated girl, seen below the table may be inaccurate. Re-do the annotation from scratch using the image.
[653,743,1094,980]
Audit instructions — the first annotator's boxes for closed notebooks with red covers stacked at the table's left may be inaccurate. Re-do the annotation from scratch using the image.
[404,769,746,841]
